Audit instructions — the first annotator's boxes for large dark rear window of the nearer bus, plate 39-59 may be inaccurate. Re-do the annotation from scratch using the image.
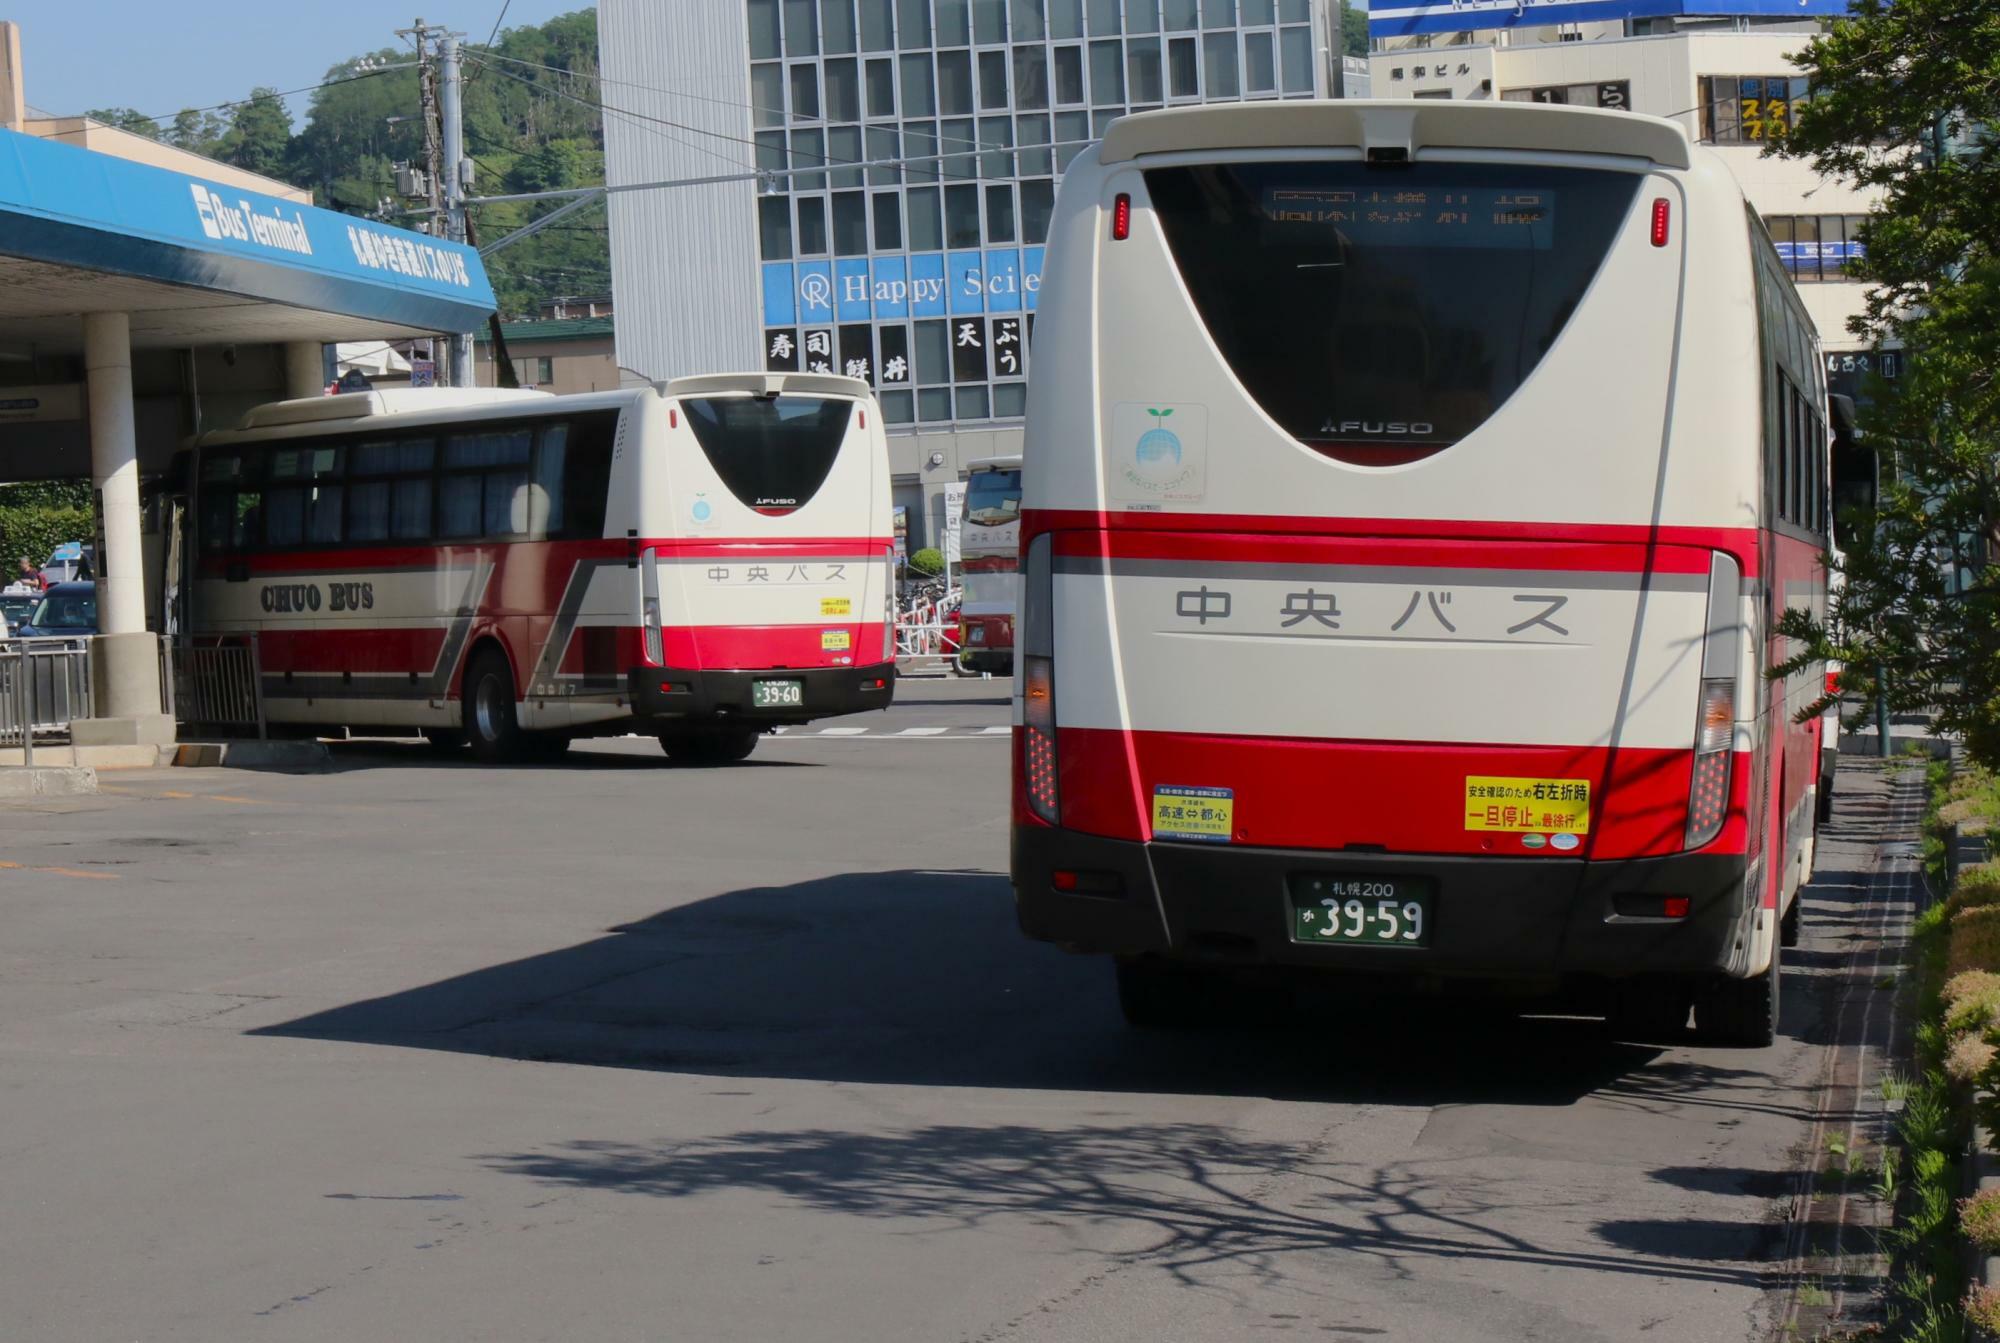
[1146,162,1638,464]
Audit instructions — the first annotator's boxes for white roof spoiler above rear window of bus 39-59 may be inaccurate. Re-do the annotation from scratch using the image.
[1098,98,1692,168]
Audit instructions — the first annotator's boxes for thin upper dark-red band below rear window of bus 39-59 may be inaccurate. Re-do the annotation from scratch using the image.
[1020,508,1762,576]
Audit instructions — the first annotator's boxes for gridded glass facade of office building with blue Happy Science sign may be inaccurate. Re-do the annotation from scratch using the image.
[744,0,1324,428]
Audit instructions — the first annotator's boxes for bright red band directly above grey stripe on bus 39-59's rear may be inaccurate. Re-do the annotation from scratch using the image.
[1054,532,1710,574]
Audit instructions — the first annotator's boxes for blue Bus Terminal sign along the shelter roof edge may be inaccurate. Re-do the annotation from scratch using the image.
[0,130,494,332]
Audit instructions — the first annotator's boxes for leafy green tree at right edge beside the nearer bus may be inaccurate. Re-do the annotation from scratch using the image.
[1768,0,2000,767]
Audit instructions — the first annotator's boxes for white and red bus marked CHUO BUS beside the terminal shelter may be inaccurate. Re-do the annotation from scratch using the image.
[188,374,896,761]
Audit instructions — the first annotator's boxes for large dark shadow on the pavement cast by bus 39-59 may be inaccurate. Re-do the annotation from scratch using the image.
[258,869,1800,1107]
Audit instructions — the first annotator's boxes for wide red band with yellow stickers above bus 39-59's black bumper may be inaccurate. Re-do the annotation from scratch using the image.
[1056,727,1752,859]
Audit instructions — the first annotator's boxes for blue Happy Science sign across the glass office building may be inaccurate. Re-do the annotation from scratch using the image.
[762,248,1042,326]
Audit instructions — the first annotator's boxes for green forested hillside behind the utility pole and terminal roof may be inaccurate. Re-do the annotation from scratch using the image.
[90,8,610,318]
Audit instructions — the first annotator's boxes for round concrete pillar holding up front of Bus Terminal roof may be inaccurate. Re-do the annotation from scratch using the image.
[74,312,174,745]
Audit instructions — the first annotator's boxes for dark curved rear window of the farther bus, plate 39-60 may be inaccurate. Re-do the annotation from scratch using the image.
[680,396,854,514]
